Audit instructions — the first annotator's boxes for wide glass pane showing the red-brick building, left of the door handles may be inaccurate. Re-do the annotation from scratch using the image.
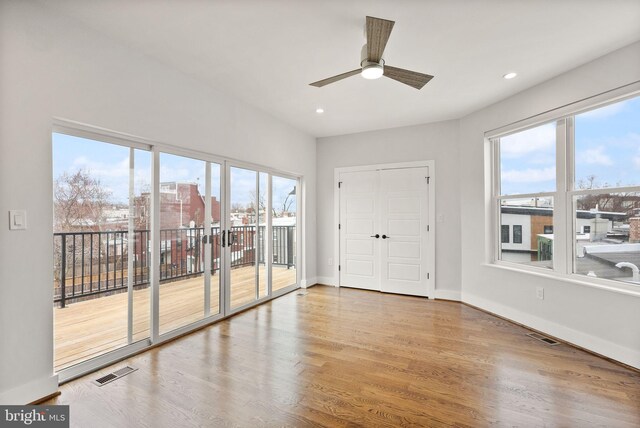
[159,153,206,334]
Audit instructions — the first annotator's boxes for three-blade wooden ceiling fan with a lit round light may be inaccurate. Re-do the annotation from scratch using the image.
[310,16,433,89]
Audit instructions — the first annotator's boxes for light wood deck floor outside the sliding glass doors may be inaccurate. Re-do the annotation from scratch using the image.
[54,266,296,371]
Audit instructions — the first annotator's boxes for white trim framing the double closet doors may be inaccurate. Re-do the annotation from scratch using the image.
[332,160,437,299]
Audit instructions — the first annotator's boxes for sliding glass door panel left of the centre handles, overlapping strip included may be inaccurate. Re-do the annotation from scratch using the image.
[156,153,221,334]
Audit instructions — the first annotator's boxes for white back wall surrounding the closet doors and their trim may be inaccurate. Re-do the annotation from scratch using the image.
[317,121,460,299]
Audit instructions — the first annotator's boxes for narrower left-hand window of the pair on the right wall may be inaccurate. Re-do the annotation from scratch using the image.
[493,123,556,268]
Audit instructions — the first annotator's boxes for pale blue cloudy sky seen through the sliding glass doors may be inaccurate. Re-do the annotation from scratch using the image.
[53,133,296,210]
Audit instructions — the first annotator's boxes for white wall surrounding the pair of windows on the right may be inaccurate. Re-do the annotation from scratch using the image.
[459,43,640,367]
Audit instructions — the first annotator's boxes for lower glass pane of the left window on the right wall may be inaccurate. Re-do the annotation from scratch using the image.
[500,197,553,269]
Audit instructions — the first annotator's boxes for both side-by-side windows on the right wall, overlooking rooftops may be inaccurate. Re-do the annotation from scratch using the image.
[491,96,640,287]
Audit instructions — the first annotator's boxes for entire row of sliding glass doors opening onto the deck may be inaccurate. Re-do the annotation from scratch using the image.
[52,130,299,379]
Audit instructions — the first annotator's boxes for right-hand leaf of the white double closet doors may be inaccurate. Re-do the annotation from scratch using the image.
[378,167,429,296]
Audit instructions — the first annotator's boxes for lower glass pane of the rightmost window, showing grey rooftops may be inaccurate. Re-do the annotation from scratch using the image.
[574,192,640,285]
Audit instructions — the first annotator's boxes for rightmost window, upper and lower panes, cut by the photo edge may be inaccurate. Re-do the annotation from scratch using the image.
[569,97,640,285]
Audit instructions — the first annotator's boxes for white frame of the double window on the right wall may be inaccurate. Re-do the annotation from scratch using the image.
[485,87,640,295]
